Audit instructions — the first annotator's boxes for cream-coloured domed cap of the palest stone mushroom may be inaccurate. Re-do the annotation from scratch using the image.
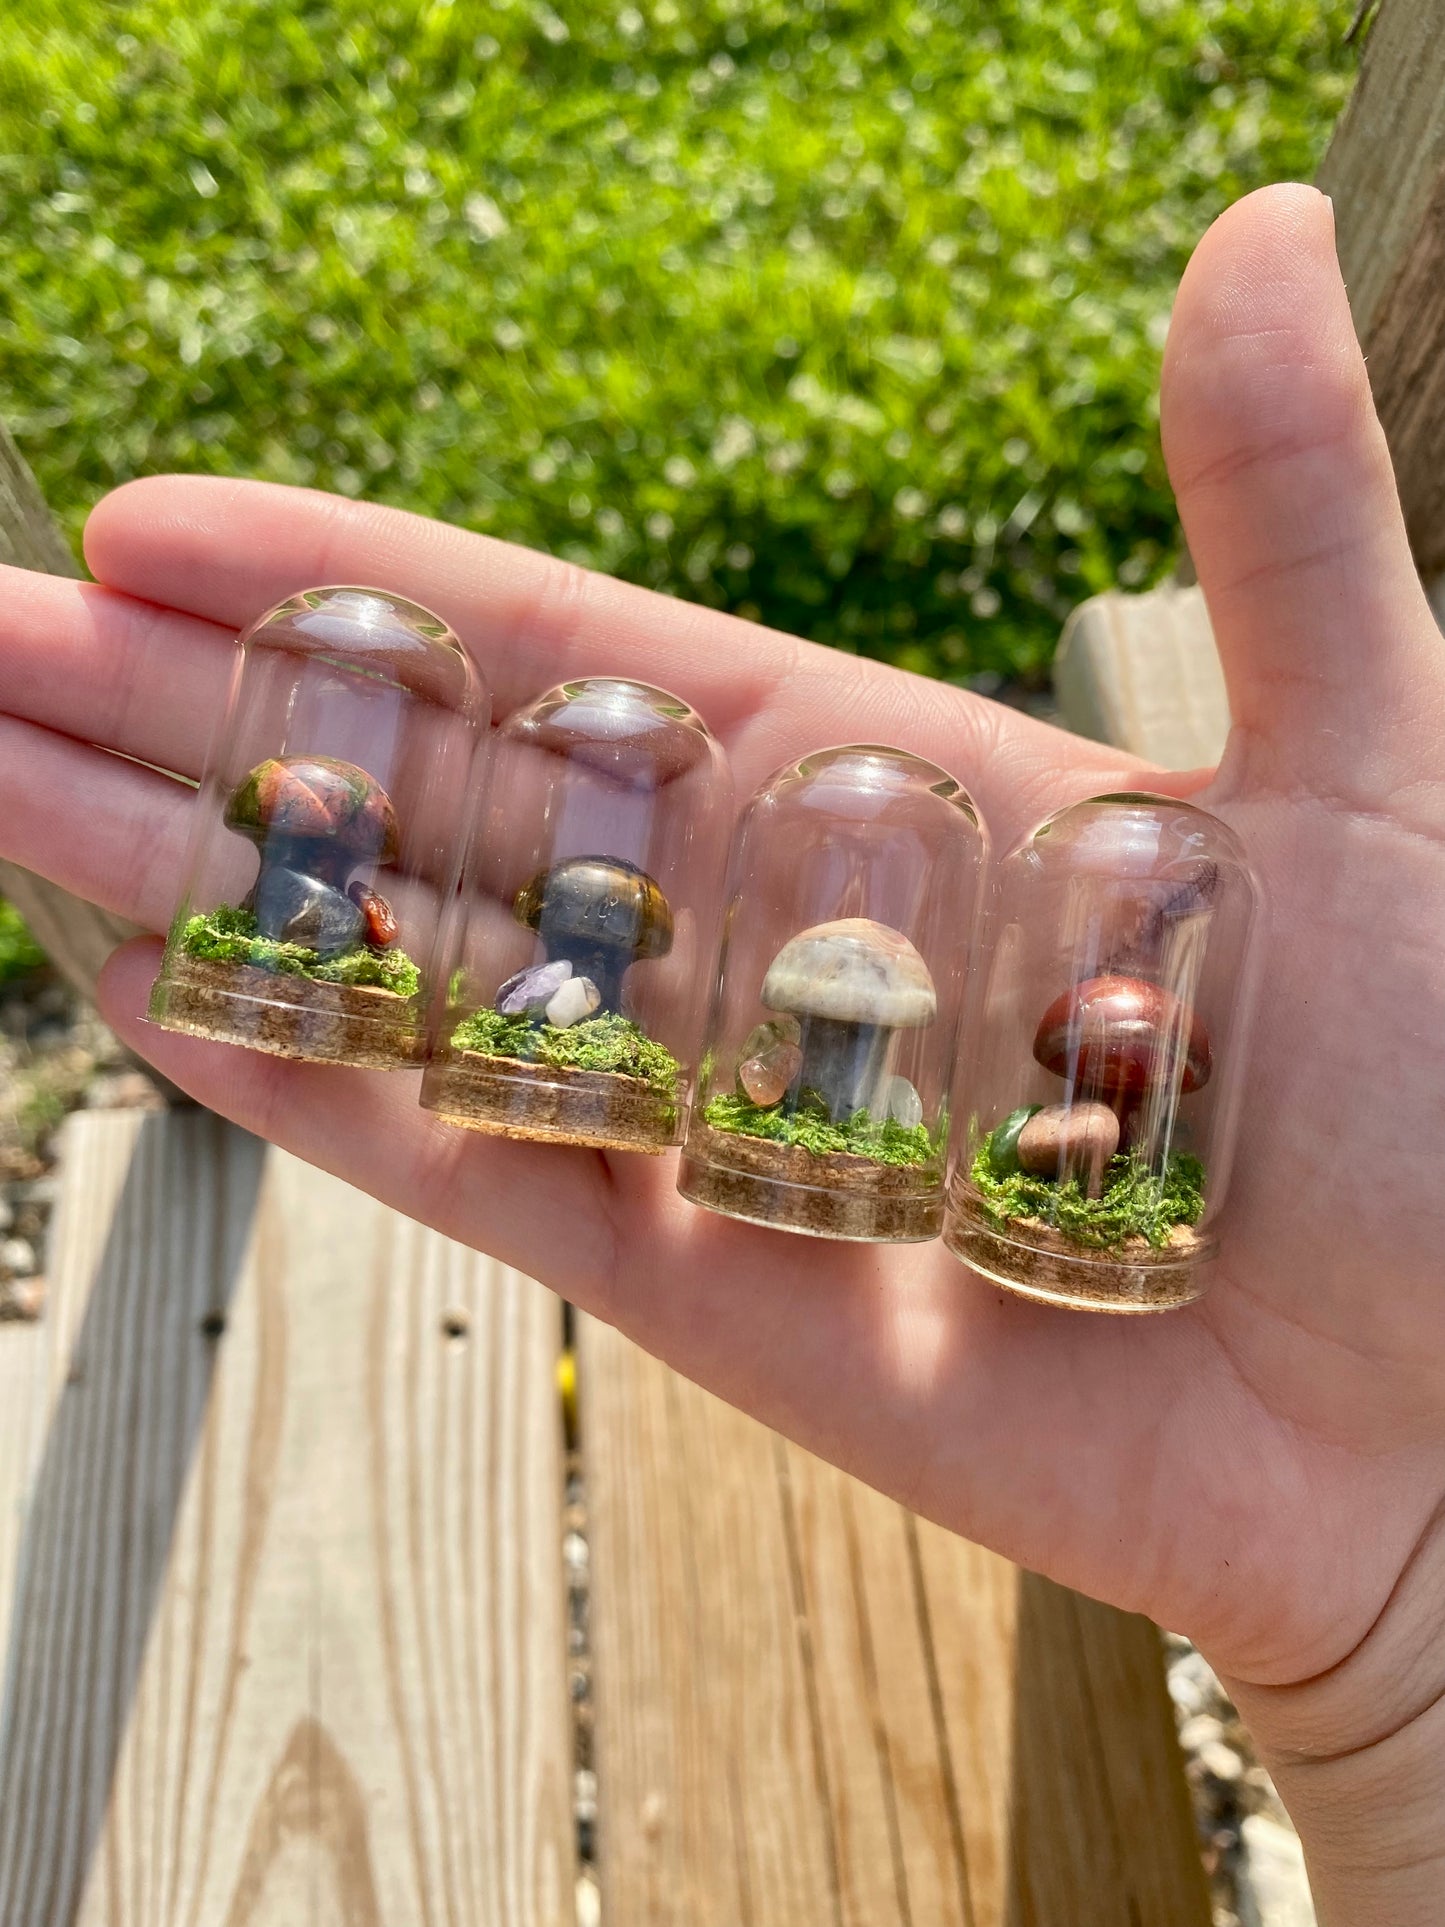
[763,917,938,1031]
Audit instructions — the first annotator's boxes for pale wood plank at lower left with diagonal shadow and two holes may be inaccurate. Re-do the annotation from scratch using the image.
[0,1112,574,1927]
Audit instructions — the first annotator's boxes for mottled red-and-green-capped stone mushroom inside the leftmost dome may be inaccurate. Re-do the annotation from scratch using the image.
[223,755,401,956]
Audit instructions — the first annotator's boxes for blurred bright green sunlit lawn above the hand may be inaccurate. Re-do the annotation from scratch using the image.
[0,0,1354,676]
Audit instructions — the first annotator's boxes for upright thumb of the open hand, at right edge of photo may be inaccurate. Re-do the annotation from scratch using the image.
[1162,187,1445,800]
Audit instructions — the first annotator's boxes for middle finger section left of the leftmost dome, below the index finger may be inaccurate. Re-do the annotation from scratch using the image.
[0,565,235,777]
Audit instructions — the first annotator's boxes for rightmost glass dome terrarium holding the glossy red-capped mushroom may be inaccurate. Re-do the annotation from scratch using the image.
[944,796,1254,1312]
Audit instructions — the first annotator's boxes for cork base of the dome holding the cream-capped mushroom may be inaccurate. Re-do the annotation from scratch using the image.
[678,1120,944,1245]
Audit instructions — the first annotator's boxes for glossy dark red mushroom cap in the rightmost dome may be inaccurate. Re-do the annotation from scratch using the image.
[1033,977,1210,1096]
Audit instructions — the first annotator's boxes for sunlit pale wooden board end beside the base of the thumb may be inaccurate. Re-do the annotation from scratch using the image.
[1054,584,1229,769]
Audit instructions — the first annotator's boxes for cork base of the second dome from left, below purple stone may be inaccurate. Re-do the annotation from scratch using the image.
[422,1050,682,1156]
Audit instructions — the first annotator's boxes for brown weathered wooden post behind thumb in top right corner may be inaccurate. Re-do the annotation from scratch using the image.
[1320,0,1445,576]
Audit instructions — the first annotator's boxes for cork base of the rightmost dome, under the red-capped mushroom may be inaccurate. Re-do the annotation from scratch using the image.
[944,1191,1214,1312]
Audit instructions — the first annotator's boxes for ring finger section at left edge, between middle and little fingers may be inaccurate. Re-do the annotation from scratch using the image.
[0,717,195,931]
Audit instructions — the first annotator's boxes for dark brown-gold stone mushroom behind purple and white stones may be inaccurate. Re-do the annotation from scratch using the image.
[512,856,672,1014]
